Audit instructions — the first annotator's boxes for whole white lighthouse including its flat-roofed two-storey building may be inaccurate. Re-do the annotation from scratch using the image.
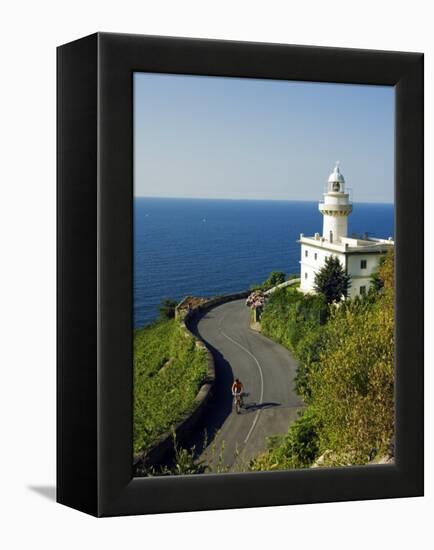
[298,163,394,297]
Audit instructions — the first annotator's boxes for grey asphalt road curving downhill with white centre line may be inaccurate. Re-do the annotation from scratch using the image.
[188,300,302,470]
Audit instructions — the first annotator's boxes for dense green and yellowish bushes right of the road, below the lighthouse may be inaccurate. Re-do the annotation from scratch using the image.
[252,253,394,470]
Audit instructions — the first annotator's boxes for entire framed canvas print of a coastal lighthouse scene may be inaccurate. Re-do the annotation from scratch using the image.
[57,33,423,516]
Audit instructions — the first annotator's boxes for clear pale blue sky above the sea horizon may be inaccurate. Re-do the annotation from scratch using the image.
[134,73,395,202]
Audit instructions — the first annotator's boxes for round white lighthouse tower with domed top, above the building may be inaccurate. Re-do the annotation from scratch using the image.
[318,161,353,243]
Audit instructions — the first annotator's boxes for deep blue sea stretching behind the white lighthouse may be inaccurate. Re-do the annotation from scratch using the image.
[134,198,394,328]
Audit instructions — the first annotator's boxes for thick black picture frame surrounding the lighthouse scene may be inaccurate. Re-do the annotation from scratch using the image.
[57,33,423,516]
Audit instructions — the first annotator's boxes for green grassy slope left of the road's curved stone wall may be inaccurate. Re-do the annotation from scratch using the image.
[134,319,207,453]
